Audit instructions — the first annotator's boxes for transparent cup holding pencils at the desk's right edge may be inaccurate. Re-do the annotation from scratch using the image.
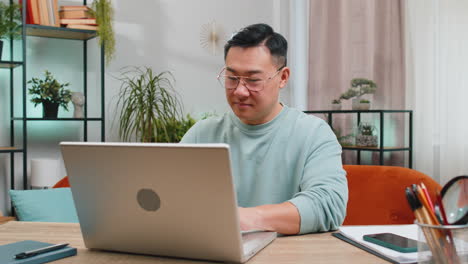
[415,221,468,264]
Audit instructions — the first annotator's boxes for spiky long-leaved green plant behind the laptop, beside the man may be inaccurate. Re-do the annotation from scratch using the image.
[114,67,195,142]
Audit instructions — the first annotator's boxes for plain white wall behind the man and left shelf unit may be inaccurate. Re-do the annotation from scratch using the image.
[0,0,290,213]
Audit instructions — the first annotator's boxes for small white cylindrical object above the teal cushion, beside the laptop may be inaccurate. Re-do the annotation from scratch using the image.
[31,159,62,189]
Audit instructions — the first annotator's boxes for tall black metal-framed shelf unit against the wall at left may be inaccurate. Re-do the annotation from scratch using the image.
[0,0,105,194]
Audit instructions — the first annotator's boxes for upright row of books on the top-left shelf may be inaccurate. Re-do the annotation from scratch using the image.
[20,0,60,27]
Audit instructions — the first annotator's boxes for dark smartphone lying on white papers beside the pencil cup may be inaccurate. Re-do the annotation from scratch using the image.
[363,233,418,253]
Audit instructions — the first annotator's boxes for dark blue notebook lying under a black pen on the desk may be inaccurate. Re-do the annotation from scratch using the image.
[0,240,76,264]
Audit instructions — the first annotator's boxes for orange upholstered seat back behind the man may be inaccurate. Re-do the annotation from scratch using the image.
[54,165,441,225]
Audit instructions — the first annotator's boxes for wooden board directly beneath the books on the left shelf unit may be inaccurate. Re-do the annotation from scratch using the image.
[26,24,96,40]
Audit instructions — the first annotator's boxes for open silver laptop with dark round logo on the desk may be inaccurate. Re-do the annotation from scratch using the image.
[60,142,276,263]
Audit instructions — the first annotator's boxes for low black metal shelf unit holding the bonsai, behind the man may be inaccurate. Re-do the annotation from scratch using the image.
[304,110,413,168]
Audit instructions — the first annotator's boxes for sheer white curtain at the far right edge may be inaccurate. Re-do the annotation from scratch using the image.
[406,0,468,184]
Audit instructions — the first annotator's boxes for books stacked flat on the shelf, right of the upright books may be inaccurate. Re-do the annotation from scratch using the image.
[59,5,97,30]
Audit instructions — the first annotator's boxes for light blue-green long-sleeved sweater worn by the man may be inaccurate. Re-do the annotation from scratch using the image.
[181,106,348,234]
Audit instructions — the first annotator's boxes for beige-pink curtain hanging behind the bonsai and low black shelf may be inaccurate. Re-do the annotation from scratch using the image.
[308,0,408,165]
